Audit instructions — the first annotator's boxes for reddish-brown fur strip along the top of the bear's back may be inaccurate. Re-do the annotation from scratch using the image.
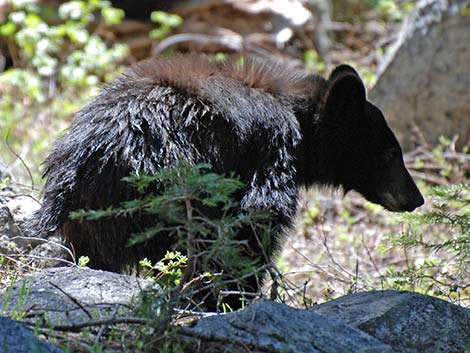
[125,55,326,102]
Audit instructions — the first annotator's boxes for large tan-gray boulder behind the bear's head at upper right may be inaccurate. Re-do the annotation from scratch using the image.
[370,0,470,146]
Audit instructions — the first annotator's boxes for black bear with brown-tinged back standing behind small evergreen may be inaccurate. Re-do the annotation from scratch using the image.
[38,55,424,302]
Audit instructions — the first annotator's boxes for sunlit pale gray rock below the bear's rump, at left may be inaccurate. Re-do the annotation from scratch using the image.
[0,267,151,325]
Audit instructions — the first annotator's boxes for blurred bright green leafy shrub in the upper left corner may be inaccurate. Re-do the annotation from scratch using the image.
[0,0,127,78]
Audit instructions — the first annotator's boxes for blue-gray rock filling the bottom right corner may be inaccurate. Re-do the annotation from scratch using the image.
[312,290,470,353]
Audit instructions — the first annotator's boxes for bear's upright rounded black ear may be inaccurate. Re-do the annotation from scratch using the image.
[325,68,366,122]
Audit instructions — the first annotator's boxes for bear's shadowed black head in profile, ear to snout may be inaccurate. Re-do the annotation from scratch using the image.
[321,65,424,212]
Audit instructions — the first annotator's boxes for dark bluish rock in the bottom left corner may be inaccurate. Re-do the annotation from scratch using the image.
[0,317,65,353]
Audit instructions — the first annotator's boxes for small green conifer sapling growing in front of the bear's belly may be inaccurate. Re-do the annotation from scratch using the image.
[72,164,272,310]
